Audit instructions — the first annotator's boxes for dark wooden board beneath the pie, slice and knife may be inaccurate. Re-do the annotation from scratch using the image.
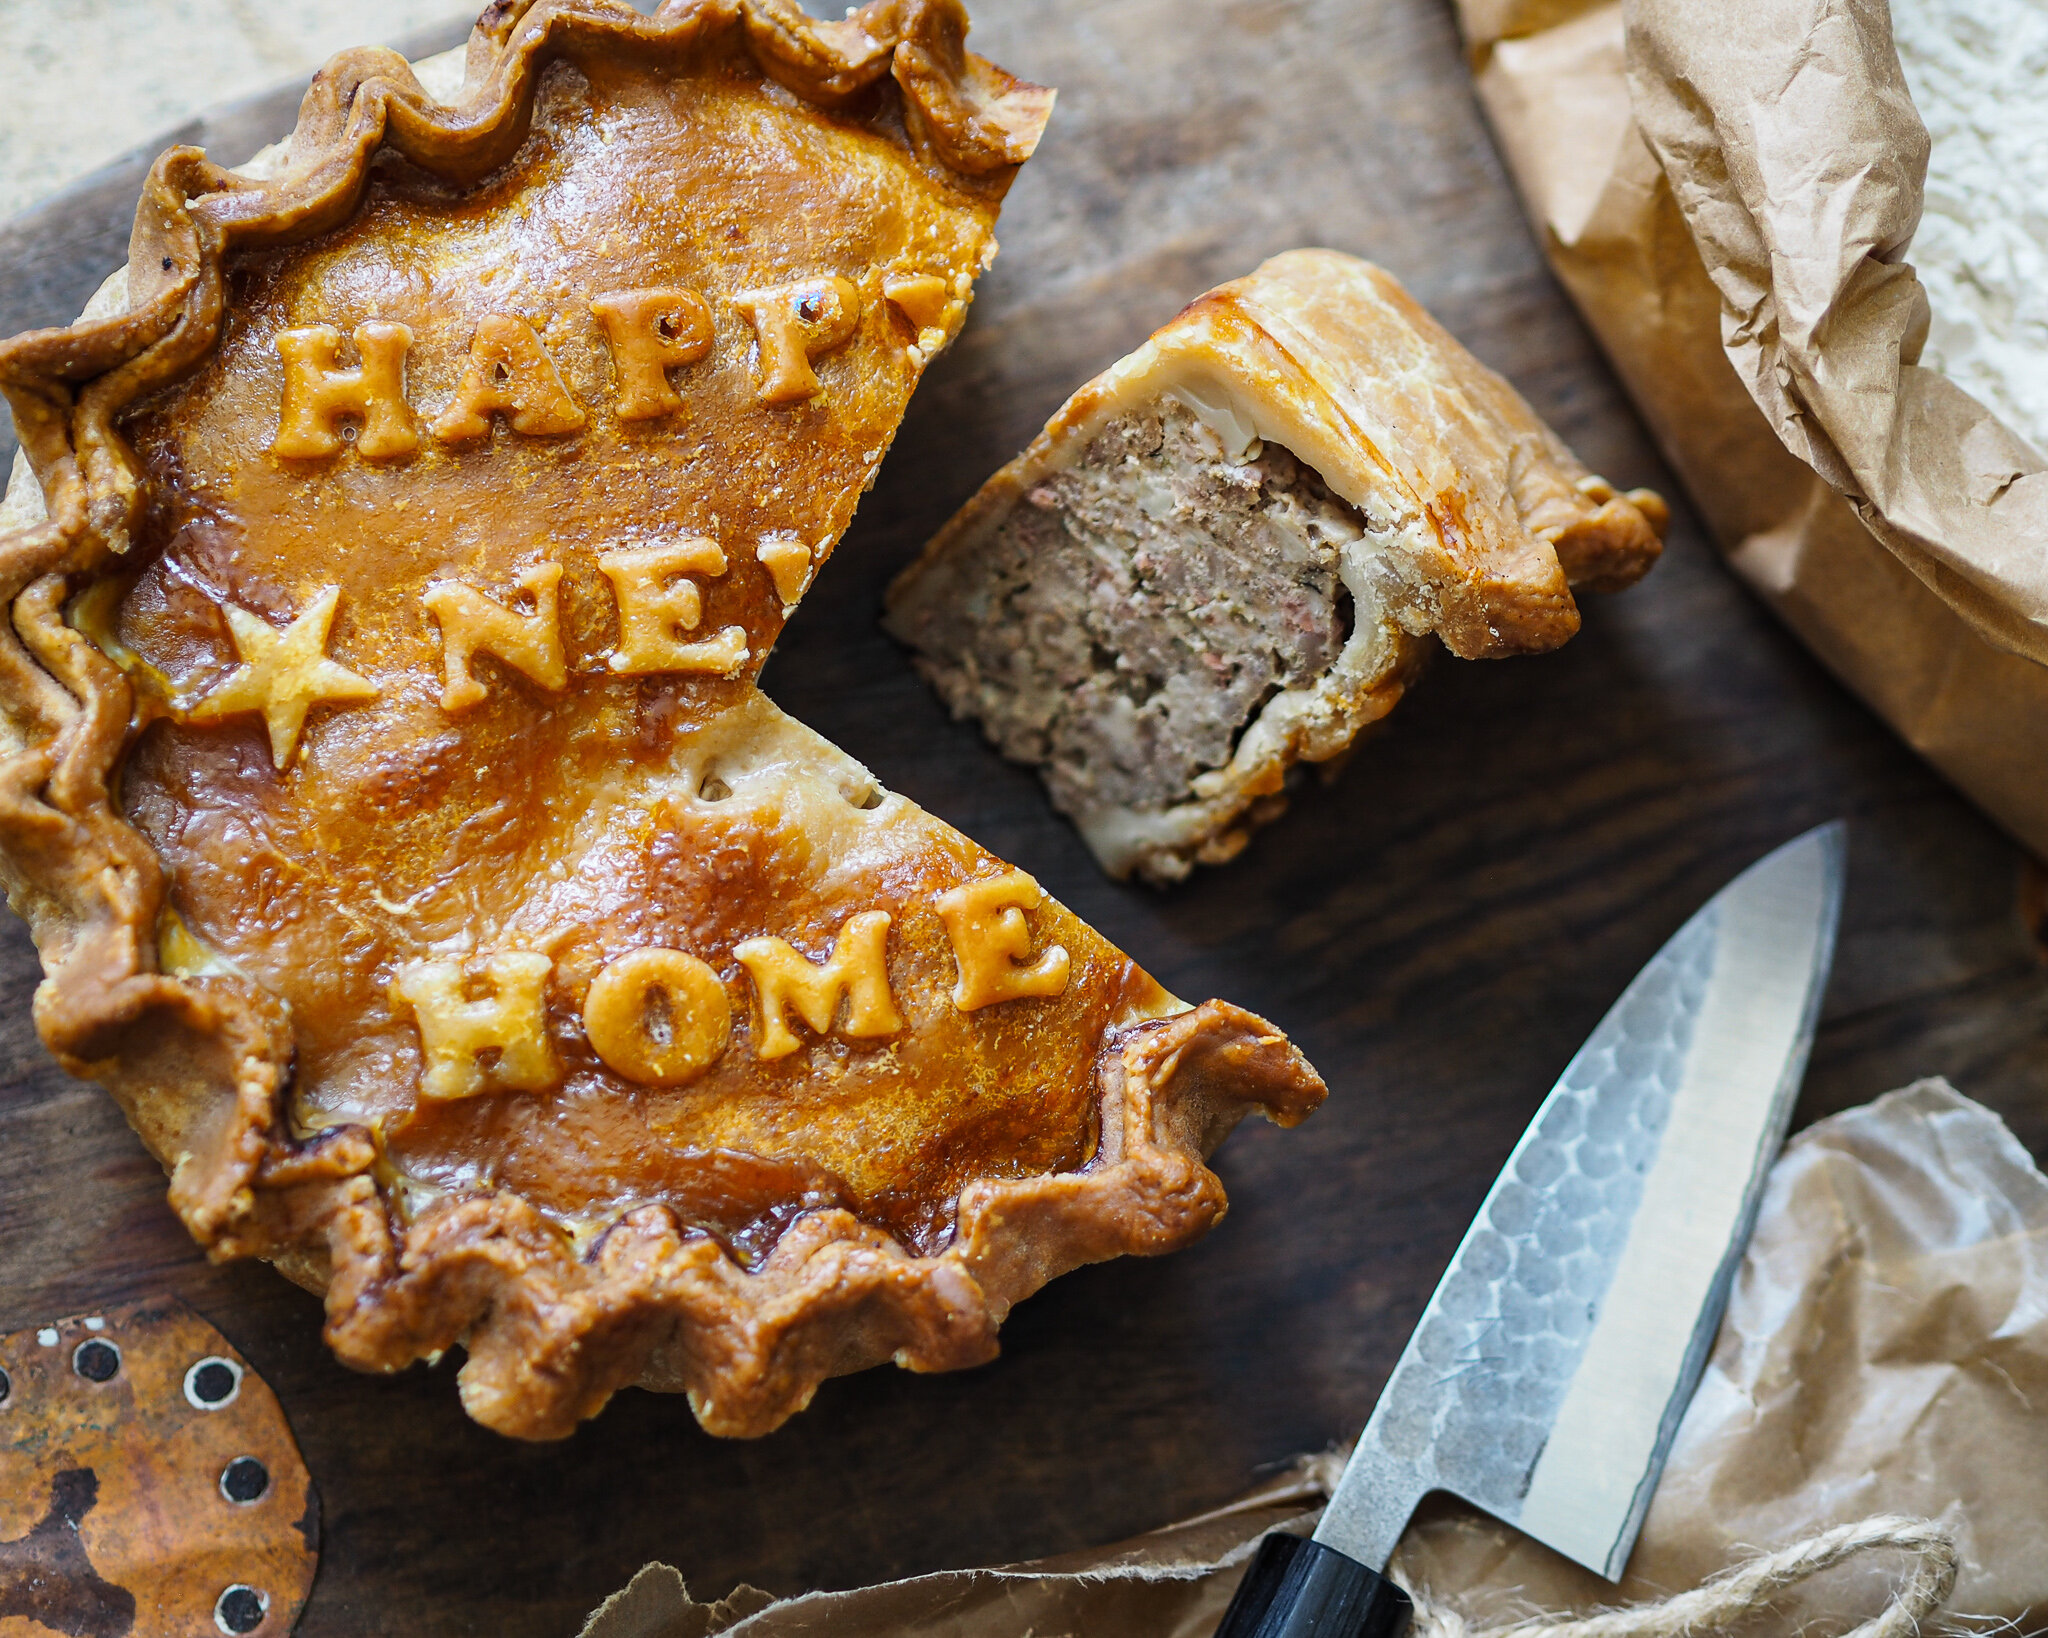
[0,0,2048,1638]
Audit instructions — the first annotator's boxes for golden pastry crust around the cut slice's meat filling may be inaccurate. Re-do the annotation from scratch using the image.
[887,250,1669,880]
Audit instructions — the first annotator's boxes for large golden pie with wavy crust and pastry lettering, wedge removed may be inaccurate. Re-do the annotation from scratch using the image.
[0,0,1323,1437]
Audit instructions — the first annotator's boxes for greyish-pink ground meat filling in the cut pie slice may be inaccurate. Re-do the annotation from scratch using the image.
[928,399,1362,815]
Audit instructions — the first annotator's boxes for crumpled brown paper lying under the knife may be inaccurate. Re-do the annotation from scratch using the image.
[584,1081,2048,1638]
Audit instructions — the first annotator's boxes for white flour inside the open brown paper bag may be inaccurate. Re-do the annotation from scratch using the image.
[1892,0,2048,450]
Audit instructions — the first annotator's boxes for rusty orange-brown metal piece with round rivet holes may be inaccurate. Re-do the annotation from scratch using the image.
[0,1300,319,1638]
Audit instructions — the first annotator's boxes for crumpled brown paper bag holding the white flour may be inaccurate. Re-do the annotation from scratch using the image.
[1458,0,2048,856]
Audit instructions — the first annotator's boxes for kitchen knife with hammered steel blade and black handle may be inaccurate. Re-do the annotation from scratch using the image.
[1217,821,1845,1638]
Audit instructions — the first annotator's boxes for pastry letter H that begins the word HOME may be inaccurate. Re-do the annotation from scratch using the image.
[391,950,561,1104]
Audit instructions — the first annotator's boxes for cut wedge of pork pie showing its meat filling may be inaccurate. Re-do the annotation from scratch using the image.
[889,250,1667,880]
